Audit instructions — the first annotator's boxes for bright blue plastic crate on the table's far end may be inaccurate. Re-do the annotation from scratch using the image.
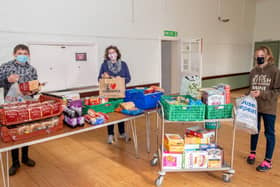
[124,89,163,110]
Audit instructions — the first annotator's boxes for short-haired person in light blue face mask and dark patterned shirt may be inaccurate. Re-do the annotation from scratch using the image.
[0,44,38,176]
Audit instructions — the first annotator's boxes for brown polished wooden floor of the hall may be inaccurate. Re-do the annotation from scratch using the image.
[0,91,280,187]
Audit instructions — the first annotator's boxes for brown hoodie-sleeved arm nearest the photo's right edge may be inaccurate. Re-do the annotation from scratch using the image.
[260,70,280,99]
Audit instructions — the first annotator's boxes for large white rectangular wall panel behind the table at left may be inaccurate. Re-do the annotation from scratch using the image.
[29,44,98,91]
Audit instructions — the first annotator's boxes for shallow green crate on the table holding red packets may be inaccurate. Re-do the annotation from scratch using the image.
[83,99,123,115]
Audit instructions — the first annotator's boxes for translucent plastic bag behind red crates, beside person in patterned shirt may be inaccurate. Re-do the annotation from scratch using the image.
[4,82,33,103]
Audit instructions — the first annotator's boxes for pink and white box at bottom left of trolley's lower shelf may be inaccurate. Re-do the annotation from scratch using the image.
[162,152,182,169]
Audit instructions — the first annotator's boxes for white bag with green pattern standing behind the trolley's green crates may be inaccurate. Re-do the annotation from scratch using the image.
[180,75,201,98]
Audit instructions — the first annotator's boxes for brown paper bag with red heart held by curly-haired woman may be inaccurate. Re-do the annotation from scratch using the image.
[99,77,125,98]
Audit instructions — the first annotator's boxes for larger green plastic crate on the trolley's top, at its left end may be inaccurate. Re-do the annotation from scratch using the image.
[160,95,205,121]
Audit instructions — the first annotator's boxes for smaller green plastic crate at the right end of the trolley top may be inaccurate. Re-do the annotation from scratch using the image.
[206,104,233,119]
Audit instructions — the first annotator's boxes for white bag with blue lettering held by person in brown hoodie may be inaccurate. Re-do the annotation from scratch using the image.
[235,96,258,134]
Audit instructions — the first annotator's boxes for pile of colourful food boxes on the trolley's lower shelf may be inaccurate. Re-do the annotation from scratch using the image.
[162,126,223,169]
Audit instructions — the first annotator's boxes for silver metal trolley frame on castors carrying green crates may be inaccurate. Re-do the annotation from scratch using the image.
[150,102,235,187]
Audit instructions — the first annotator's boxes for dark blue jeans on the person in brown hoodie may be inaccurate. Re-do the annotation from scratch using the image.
[251,113,276,160]
